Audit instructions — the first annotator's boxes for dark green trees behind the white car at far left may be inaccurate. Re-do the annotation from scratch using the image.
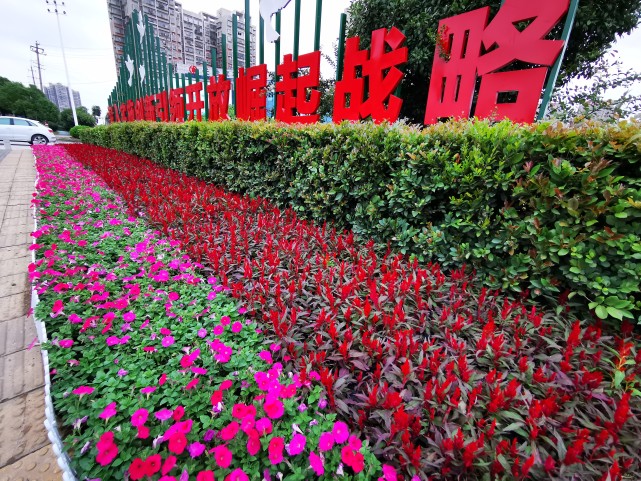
[0,77,60,128]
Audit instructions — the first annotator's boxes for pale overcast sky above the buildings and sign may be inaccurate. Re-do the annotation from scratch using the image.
[0,0,641,115]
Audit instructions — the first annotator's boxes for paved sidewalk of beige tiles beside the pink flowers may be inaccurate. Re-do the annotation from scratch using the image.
[0,148,62,481]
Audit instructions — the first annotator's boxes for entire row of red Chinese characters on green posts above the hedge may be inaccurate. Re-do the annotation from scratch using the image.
[108,4,578,124]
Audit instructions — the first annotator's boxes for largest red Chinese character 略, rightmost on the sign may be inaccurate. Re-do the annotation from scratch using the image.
[425,0,569,124]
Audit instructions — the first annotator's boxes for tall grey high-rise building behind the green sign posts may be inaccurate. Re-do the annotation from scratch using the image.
[107,0,256,72]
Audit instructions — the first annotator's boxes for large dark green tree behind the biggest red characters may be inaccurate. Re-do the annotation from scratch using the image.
[348,0,641,123]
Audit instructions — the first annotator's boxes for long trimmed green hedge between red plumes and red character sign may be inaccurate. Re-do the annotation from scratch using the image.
[81,122,641,322]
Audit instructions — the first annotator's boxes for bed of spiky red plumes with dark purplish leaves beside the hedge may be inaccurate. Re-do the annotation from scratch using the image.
[60,145,641,480]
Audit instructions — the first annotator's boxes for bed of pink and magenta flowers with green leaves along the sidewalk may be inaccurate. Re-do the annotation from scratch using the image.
[30,147,384,481]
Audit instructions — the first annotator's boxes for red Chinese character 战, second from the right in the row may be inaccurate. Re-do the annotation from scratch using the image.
[333,27,407,123]
